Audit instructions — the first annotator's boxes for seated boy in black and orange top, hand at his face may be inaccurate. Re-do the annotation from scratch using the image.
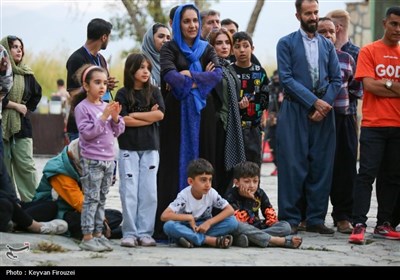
[226,161,302,249]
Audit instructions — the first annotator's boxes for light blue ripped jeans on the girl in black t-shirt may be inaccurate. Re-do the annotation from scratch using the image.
[119,150,160,238]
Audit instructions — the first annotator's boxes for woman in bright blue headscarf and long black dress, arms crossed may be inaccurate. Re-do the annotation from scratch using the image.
[156,4,222,238]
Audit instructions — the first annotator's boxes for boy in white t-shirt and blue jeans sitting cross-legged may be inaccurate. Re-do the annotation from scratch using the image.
[161,159,238,248]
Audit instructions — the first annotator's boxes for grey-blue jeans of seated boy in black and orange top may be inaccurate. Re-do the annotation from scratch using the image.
[233,221,291,248]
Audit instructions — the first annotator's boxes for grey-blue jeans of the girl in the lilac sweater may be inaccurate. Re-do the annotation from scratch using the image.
[81,158,114,234]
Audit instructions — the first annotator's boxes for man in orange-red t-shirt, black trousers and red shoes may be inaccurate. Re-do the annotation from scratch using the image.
[349,6,400,244]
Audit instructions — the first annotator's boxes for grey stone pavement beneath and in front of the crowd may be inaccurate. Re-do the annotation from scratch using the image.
[0,157,400,266]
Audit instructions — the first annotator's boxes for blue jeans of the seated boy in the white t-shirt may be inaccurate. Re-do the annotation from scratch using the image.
[164,216,238,246]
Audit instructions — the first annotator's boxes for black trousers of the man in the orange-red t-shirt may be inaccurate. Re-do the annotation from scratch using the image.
[353,127,400,226]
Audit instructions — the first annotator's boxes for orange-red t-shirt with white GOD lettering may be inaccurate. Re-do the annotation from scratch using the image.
[355,40,400,127]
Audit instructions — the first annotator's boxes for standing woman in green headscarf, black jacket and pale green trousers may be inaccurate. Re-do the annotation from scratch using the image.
[0,36,42,202]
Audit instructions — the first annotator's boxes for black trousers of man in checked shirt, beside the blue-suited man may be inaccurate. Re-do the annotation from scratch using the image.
[330,114,358,223]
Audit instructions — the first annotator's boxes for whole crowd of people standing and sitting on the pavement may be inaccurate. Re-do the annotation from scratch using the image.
[0,0,400,252]
